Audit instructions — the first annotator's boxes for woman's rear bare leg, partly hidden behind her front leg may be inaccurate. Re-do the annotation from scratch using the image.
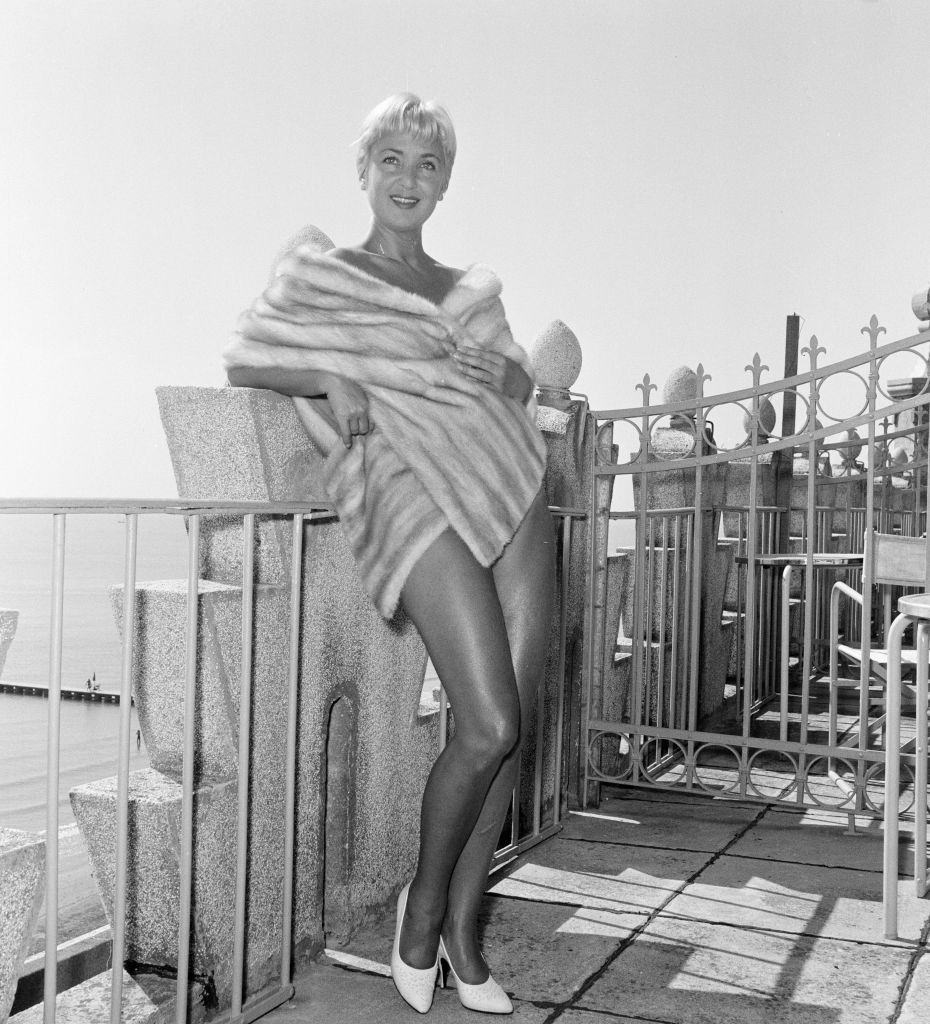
[440,495,555,984]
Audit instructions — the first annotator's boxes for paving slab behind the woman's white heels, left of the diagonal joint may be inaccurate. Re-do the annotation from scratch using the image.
[329,897,635,1002]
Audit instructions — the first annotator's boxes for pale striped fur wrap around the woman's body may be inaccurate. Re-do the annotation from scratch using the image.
[224,246,546,617]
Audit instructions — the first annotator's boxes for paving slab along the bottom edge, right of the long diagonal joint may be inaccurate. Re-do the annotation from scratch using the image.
[577,916,913,1024]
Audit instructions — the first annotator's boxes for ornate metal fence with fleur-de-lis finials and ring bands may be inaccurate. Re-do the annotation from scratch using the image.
[582,317,930,814]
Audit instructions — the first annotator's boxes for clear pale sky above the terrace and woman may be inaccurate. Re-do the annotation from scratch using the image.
[0,0,930,498]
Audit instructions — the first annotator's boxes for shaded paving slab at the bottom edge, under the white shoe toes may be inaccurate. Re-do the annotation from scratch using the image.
[262,964,551,1024]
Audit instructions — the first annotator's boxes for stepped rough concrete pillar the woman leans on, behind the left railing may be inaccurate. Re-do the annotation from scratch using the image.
[61,388,438,1005]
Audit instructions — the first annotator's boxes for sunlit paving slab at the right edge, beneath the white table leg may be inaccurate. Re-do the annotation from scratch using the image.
[663,856,930,943]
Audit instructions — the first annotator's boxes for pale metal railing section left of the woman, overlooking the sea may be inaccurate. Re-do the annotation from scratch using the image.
[0,499,332,1024]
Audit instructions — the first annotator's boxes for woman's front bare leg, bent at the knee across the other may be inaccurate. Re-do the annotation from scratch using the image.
[400,530,520,966]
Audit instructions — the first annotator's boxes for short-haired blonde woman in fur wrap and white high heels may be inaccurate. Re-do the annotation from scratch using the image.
[227,93,554,1013]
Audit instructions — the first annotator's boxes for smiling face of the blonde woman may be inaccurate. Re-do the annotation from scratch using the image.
[366,132,447,231]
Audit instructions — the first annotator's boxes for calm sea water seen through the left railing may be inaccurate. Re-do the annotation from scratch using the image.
[0,514,186,829]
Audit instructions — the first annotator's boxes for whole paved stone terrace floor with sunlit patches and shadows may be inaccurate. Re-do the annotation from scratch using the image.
[263,790,930,1024]
